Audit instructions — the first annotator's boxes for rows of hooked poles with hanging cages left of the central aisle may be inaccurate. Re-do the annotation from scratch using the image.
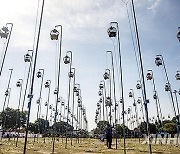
[0,0,88,154]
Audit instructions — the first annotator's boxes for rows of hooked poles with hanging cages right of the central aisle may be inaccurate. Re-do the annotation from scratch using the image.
[95,0,180,154]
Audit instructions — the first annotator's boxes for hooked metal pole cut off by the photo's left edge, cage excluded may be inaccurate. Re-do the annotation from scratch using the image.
[0,23,13,76]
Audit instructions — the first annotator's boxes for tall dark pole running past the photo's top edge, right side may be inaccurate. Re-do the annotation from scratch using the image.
[131,0,152,154]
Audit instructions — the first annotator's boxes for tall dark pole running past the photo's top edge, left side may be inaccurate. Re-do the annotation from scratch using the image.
[23,0,45,154]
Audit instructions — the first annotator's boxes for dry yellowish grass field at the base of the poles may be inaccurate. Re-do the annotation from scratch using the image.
[0,138,180,154]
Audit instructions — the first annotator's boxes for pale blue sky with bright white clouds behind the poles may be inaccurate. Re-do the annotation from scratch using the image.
[0,0,180,130]
